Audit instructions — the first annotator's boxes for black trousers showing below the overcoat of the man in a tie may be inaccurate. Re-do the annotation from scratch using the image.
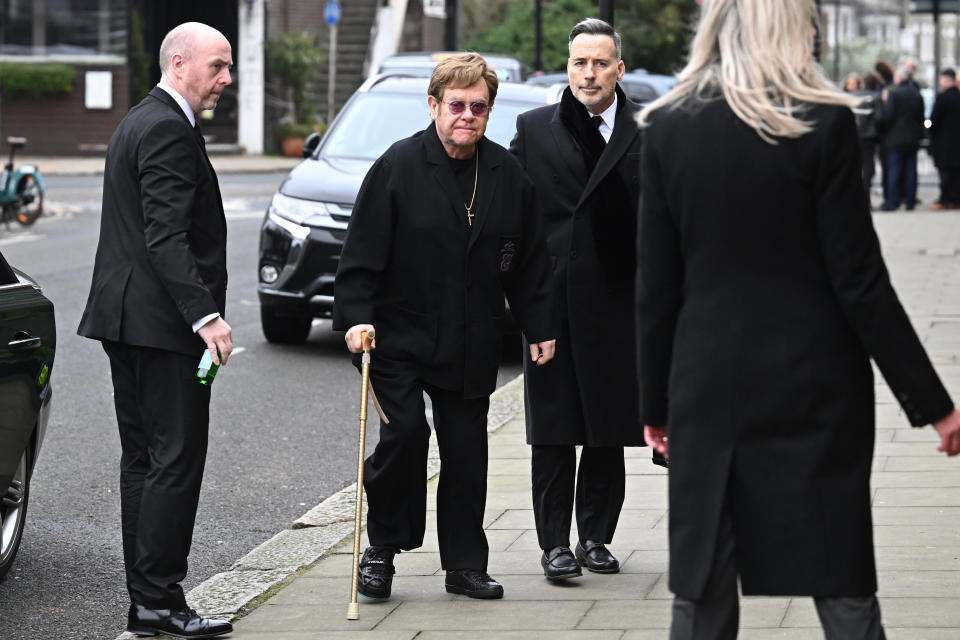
[531,445,626,551]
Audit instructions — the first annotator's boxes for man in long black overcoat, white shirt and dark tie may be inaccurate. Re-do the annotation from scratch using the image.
[510,18,644,580]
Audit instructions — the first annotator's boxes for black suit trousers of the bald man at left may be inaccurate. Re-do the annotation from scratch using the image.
[103,341,210,609]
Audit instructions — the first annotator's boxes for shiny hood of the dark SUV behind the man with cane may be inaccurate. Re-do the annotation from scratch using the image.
[280,156,373,206]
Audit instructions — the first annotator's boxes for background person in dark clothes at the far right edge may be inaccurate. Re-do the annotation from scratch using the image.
[930,69,960,211]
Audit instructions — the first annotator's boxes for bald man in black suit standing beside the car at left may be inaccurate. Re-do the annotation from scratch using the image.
[78,23,233,638]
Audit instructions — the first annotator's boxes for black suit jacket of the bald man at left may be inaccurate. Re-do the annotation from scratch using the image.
[77,87,227,357]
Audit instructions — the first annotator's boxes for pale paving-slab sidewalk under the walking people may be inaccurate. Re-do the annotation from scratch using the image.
[210,209,960,640]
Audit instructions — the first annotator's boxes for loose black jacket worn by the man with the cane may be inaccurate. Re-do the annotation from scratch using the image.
[333,123,557,398]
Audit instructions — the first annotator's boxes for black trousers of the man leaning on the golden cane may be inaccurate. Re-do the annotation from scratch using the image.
[363,358,490,571]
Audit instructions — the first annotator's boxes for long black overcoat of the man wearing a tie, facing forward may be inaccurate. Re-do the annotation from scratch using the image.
[510,89,644,447]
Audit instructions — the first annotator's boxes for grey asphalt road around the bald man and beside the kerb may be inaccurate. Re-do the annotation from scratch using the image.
[0,174,521,640]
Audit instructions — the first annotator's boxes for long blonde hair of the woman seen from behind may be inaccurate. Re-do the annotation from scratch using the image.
[637,0,860,144]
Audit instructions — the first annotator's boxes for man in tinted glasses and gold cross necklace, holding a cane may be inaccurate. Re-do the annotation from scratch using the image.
[333,53,557,599]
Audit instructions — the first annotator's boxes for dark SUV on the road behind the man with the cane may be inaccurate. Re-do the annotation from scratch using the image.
[258,76,548,343]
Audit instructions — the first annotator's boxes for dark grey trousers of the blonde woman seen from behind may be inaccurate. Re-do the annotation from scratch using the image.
[670,502,885,640]
